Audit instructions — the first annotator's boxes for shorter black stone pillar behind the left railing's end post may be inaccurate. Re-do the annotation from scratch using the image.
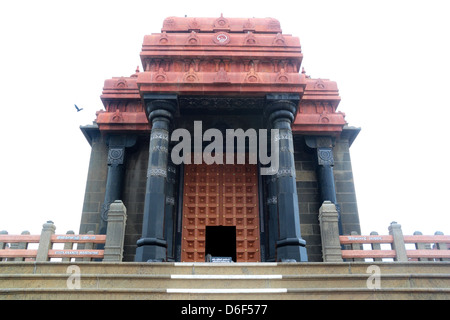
[99,134,136,234]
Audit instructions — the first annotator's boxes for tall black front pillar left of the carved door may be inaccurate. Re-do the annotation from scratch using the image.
[135,95,177,262]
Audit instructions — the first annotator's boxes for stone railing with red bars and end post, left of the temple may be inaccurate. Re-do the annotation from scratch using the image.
[0,200,126,262]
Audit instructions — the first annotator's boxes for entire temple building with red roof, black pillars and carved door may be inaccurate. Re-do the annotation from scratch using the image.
[80,16,360,262]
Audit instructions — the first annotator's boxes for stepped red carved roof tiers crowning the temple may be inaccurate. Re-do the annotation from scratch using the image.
[97,16,346,134]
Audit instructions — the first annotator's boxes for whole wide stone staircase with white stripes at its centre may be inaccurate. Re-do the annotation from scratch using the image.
[0,262,450,300]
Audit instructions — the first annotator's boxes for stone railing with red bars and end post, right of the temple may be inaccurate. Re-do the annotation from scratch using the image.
[319,201,450,262]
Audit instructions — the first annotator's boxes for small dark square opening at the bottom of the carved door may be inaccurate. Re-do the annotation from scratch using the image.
[205,226,236,262]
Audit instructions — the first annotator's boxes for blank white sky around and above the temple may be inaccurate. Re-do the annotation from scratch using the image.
[0,0,450,238]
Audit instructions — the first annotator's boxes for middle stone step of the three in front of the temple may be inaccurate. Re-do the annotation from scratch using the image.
[0,274,450,289]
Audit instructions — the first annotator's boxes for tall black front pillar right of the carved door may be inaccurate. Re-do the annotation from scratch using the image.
[265,94,308,262]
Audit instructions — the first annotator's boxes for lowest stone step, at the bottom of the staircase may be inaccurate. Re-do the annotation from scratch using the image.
[0,288,450,303]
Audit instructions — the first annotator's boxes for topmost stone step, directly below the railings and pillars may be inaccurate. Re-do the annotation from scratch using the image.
[0,261,450,275]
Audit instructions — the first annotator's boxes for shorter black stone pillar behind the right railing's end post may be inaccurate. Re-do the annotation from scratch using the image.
[305,136,342,234]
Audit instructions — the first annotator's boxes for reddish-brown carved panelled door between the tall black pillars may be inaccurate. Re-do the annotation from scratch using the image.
[181,164,261,262]
